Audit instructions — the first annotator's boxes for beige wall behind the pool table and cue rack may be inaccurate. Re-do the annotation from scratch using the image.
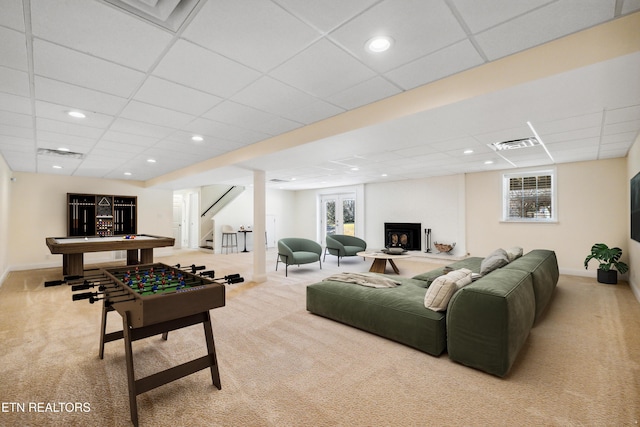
[8,172,173,270]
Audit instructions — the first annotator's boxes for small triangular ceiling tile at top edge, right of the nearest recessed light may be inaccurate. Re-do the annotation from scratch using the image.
[452,0,551,33]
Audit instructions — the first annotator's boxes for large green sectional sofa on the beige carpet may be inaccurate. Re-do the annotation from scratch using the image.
[307,249,559,377]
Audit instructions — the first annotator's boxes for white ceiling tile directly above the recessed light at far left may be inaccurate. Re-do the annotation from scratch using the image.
[35,76,127,115]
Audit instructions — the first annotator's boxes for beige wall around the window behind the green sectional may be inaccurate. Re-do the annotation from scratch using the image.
[466,158,629,276]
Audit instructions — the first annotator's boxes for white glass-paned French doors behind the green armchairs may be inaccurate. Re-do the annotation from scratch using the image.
[320,193,356,241]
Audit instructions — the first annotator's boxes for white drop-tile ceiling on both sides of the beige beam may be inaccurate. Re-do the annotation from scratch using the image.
[0,0,640,189]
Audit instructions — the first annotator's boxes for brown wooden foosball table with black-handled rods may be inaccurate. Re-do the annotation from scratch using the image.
[69,263,244,426]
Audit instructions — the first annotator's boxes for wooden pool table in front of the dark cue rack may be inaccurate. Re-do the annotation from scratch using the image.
[46,234,175,276]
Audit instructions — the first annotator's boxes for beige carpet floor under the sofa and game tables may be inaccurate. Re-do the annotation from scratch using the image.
[0,251,640,426]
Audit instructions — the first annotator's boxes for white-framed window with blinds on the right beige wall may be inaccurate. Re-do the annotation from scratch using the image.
[503,169,558,222]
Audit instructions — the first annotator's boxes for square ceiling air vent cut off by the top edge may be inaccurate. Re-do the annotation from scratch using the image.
[105,0,200,32]
